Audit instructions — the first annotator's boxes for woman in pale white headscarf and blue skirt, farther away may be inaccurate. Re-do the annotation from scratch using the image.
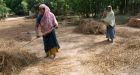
[103,6,116,43]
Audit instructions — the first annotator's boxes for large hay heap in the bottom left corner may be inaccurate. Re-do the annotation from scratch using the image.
[0,41,39,75]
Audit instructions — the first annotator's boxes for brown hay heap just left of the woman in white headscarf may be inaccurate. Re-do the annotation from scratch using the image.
[76,19,106,34]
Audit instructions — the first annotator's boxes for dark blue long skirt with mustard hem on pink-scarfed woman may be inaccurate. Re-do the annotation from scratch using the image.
[43,30,60,56]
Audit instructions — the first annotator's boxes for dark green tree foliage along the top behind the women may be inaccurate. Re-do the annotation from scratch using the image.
[0,0,140,17]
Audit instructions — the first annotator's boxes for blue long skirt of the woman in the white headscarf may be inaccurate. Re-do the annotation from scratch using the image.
[106,25,115,39]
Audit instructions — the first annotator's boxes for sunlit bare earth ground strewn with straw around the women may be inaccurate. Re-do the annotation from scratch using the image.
[0,20,140,75]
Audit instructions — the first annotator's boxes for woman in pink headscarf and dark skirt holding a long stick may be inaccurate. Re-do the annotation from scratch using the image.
[35,4,60,58]
